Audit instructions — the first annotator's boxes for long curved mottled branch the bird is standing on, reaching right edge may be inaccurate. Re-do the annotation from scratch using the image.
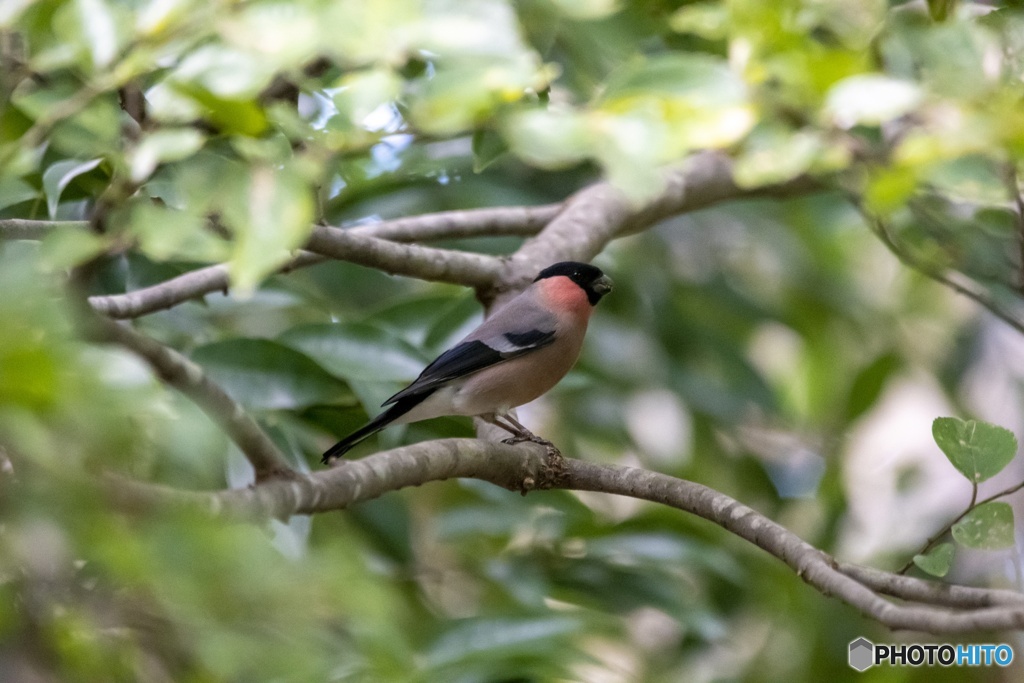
[101,439,1024,633]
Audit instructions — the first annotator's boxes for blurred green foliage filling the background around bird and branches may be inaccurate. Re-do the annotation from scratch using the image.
[0,0,1024,682]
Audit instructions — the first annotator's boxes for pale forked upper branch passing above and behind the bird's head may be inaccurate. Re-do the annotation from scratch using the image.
[89,152,814,318]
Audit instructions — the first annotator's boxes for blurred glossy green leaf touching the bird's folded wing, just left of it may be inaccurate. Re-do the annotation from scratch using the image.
[278,323,426,382]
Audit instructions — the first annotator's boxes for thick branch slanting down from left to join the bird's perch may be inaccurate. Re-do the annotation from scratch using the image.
[89,315,293,481]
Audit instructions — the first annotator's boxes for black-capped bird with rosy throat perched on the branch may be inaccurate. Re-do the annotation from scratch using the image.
[323,261,612,464]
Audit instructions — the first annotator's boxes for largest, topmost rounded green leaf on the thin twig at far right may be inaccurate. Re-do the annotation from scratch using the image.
[932,418,1017,483]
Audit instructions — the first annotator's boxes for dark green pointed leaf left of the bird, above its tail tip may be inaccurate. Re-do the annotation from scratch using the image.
[191,339,351,411]
